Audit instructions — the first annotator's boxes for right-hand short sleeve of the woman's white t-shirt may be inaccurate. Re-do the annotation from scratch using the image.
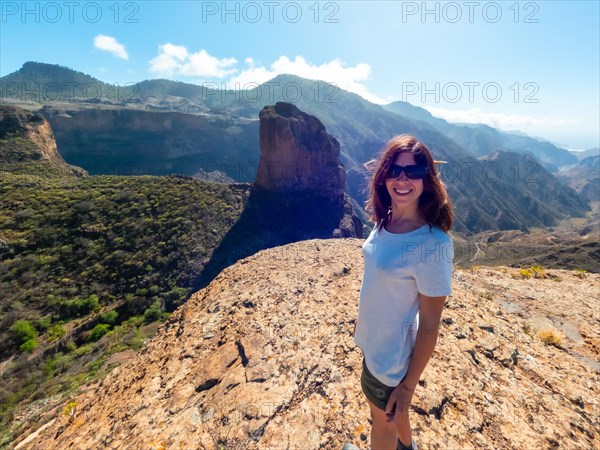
[415,235,454,297]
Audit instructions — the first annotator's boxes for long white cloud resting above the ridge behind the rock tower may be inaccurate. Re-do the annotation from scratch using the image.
[227,56,388,104]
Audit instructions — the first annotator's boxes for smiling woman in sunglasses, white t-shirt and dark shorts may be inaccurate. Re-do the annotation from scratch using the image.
[354,135,454,450]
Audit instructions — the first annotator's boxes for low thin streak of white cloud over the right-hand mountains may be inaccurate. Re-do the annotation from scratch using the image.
[425,107,575,130]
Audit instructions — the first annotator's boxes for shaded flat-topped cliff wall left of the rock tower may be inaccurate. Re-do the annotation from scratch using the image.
[39,105,259,182]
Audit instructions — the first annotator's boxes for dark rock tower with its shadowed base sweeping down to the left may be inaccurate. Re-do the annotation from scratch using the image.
[197,103,363,288]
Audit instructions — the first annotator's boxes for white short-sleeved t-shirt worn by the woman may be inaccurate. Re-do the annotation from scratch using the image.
[354,224,454,387]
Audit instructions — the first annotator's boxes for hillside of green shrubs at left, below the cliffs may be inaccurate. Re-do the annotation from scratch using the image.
[0,172,248,436]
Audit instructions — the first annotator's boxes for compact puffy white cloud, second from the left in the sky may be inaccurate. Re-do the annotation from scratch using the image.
[150,43,237,78]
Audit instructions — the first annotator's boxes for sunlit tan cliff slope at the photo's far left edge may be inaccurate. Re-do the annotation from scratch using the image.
[0,106,87,177]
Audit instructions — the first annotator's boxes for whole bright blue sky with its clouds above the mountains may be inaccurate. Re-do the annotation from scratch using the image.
[0,1,600,149]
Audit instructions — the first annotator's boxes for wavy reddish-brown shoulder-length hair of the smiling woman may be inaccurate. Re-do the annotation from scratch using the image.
[365,134,454,233]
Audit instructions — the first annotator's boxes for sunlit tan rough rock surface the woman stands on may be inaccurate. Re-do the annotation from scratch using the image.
[14,239,600,450]
